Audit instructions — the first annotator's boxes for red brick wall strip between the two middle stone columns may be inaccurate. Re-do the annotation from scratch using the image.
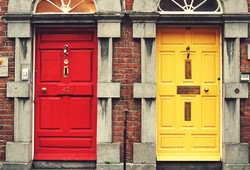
[113,17,141,162]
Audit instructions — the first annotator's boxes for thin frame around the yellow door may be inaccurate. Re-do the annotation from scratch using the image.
[155,24,224,161]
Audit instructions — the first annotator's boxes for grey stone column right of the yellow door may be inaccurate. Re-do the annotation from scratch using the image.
[222,23,249,170]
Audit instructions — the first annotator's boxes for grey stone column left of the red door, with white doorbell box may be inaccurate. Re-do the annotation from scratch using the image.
[3,20,33,170]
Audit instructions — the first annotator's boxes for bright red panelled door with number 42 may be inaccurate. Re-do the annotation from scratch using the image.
[34,28,97,160]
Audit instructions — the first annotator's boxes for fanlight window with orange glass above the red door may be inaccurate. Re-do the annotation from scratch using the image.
[35,0,97,14]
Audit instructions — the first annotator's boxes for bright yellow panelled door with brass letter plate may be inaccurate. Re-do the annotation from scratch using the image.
[157,27,220,161]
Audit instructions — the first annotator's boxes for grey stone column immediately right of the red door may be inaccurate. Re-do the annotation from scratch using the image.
[97,16,122,166]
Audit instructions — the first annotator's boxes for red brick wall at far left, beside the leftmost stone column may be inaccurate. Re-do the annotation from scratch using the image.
[0,0,14,161]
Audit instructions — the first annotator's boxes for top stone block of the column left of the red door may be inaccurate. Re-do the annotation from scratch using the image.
[7,21,31,38]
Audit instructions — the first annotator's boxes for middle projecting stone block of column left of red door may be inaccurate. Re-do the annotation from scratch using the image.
[7,82,30,98]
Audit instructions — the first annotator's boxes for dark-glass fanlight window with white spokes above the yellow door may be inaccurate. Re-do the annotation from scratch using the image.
[158,0,222,14]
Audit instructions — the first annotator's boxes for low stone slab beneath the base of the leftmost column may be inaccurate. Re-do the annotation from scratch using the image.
[3,162,32,170]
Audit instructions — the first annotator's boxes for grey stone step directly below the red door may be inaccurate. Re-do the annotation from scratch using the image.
[32,161,96,170]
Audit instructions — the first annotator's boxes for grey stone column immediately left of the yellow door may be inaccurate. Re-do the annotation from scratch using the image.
[131,15,156,169]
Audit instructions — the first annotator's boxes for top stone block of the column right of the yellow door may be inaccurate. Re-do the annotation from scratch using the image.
[224,22,248,38]
